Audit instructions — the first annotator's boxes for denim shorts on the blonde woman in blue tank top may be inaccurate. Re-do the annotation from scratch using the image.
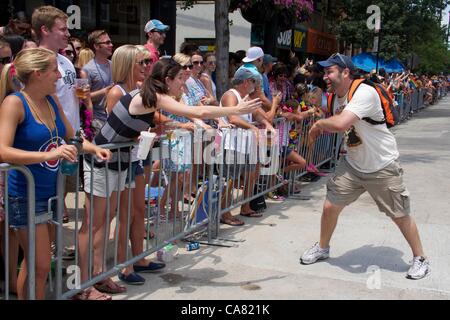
[8,196,56,229]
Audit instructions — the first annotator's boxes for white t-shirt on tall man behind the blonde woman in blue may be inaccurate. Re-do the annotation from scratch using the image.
[56,54,80,131]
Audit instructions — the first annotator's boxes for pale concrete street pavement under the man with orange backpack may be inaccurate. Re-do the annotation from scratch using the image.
[114,97,450,300]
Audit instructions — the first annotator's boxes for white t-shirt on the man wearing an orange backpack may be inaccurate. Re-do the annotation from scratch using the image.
[333,84,399,173]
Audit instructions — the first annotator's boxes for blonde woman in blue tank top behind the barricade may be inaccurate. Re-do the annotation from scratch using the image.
[0,48,110,299]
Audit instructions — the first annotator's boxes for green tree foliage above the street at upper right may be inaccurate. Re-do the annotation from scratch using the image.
[332,0,450,72]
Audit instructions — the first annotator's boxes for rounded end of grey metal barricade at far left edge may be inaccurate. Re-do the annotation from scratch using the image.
[0,163,36,300]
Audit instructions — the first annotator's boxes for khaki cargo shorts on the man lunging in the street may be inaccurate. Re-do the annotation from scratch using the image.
[327,159,410,218]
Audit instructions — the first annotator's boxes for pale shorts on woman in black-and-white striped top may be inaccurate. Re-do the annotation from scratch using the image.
[83,160,128,198]
